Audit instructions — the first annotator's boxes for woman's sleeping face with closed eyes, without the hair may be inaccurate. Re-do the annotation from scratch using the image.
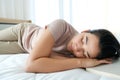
[67,32,99,58]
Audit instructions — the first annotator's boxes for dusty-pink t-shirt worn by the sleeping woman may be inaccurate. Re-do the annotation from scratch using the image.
[22,19,78,55]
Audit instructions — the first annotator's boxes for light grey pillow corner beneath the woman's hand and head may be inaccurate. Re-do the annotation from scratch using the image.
[86,58,120,79]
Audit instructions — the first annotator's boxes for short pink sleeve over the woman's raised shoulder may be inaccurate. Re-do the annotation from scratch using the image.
[47,19,71,41]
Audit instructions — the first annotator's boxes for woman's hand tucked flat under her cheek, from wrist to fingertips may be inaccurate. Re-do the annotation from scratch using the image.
[78,58,112,68]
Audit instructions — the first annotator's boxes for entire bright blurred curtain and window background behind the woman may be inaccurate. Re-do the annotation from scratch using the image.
[0,0,120,32]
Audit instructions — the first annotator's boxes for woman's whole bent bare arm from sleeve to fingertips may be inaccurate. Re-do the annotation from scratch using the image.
[26,29,111,72]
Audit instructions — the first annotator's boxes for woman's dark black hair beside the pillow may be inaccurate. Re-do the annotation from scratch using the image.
[89,29,120,59]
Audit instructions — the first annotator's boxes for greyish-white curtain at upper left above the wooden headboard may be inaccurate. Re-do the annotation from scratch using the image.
[0,0,34,20]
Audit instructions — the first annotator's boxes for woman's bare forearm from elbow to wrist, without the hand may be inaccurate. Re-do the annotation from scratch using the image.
[26,57,79,73]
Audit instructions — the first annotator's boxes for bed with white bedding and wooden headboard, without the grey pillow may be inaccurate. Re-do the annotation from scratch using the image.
[0,18,120,80]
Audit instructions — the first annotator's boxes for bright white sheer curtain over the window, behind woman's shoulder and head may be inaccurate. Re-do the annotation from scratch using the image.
[35,0,120,32]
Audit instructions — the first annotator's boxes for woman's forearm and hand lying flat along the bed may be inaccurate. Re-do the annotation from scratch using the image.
[26,57,110,73]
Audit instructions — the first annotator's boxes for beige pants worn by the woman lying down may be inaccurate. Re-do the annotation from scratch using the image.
[0,23,28,53]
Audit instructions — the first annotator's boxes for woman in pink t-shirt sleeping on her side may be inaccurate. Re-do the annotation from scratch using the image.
[0,19,120,72]
